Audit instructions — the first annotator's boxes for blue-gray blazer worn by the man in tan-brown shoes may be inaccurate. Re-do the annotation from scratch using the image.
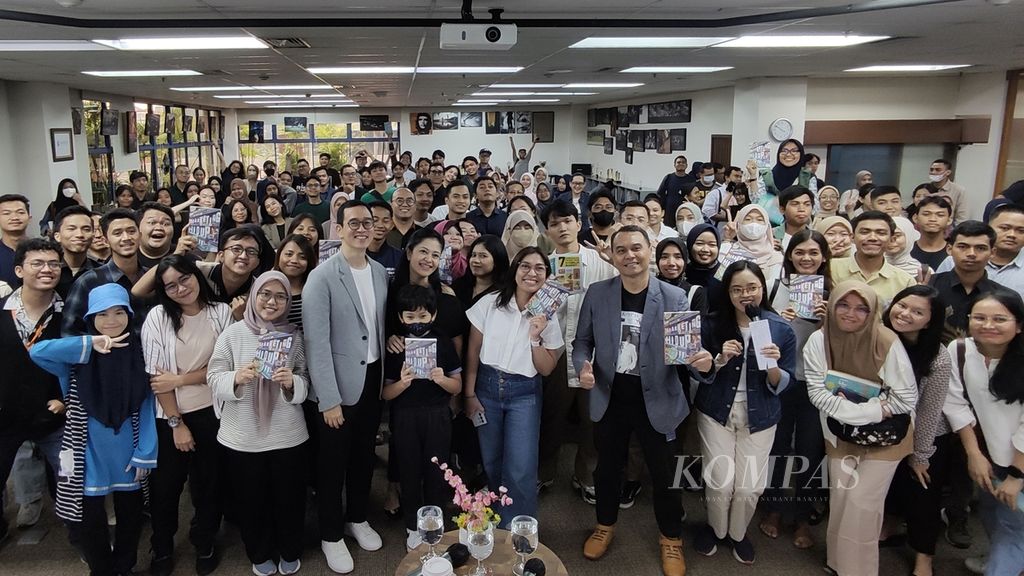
[573,277,690,432]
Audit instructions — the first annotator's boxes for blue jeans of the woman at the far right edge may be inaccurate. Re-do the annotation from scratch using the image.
[978,471,1024,576]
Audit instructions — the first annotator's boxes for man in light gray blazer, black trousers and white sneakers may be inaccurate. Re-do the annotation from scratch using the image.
[302,201,387,574]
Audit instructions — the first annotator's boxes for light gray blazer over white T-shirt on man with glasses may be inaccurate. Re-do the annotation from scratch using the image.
[302,251,387,412]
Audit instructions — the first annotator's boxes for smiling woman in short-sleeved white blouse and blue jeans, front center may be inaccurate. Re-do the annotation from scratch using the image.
[463,246,564,528]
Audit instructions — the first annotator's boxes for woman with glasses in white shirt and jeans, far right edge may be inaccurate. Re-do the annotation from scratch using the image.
[942,290,1024,576]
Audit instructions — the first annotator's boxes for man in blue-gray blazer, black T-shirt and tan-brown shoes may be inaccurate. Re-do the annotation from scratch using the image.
[572,225,713,576]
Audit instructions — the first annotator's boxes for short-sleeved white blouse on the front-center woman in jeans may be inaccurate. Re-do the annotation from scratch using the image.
[466,294,565,377]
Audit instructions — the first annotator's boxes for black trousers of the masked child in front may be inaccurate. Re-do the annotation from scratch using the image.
[391,404,452,530]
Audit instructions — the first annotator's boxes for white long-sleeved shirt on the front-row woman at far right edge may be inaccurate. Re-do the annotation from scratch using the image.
[942,338,1024,466]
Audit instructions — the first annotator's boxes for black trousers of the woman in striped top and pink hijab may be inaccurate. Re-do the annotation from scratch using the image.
[228,444,306,564]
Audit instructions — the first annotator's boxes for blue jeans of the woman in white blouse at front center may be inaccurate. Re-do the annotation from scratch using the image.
[476,364,542,528]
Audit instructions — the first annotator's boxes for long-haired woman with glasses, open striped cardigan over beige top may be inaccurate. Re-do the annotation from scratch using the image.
[142,254,231,574]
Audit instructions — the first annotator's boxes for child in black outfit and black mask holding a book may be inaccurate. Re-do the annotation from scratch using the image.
[383,285,462,549]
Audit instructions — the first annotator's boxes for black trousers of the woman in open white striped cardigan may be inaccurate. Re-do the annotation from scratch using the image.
[150,406,222,558]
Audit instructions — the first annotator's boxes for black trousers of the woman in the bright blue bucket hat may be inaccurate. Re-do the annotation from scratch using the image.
[71,490,142,576]
